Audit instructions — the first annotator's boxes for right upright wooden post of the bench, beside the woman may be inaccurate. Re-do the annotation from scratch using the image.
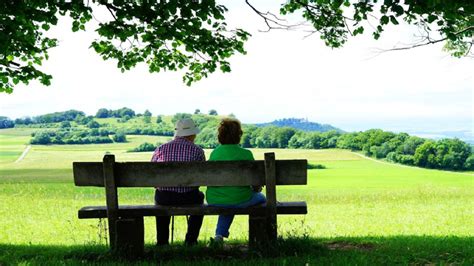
[265,152,277,242]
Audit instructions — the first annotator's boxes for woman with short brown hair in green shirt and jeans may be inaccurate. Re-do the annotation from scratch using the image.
[206,119,266,242]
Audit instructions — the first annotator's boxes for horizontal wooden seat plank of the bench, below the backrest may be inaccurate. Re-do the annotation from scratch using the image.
[78,201,308,219]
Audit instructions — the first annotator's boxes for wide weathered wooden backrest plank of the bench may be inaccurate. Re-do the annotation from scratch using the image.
[73,160,307,187]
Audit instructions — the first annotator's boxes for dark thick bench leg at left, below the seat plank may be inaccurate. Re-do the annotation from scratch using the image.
[114,217,145,258]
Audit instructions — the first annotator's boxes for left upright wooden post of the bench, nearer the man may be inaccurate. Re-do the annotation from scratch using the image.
[103,154,118,250]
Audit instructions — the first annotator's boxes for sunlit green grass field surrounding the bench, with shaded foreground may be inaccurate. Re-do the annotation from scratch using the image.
[0,129,474,265]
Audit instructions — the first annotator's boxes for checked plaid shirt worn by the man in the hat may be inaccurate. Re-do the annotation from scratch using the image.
[151,137,206,193]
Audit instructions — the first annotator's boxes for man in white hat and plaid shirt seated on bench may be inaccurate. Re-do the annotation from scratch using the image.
[151,119,206,245]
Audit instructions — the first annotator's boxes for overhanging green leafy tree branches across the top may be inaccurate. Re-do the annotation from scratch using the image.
[0,0,474,93]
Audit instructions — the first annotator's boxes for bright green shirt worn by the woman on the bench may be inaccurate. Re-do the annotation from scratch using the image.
[206,144,254,204]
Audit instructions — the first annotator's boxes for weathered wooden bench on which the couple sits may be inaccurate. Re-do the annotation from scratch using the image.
[73,153,307,255]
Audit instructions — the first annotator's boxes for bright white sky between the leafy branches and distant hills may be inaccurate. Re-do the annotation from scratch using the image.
[0,1,474,138]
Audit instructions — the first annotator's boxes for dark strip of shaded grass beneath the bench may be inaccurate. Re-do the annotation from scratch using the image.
[0,236,474,266]
